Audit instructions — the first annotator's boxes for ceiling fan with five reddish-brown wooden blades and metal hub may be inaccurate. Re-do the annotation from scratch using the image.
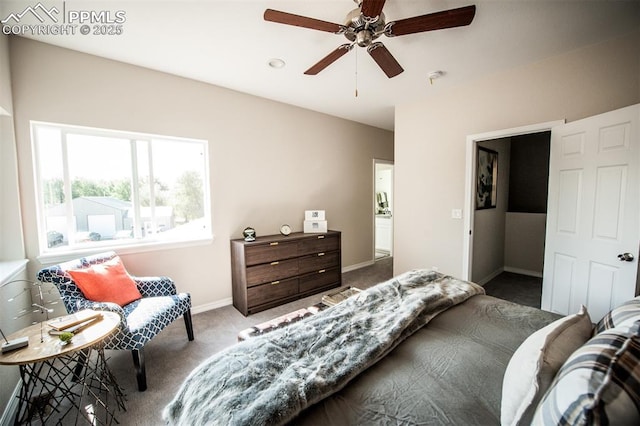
[264,0,476,78]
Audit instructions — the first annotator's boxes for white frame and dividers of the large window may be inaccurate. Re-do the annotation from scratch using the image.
[30,121,214,262]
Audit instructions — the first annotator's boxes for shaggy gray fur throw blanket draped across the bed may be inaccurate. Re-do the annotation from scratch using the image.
[163,270,484,426]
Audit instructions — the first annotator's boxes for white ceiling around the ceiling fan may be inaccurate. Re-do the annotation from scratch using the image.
[5,0,640,130]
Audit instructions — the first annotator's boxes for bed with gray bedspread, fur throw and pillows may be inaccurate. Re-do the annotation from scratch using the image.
[163,270,640,425]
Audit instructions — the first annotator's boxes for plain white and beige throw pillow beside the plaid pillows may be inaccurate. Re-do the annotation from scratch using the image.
[500,306,593,426]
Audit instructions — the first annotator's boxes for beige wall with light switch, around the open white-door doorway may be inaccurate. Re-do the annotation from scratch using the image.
[394,30,640,276]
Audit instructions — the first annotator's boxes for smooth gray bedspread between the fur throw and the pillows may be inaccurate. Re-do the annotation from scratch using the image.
[291,295,560,426]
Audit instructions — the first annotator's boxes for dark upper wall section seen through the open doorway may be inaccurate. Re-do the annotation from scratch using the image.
[508,132,551,213]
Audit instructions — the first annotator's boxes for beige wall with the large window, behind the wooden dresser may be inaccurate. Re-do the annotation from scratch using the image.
[11,37,393,309]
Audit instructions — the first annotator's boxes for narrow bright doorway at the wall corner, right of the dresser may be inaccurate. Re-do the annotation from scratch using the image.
[373,159,393,260]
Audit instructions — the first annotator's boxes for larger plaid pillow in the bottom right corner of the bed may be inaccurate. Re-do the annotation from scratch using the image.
[533,320,640,425]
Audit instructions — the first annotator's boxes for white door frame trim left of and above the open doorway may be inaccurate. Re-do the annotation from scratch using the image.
[462,119,566,281]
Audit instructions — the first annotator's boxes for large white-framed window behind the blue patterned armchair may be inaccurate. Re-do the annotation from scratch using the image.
[31,122,211,252]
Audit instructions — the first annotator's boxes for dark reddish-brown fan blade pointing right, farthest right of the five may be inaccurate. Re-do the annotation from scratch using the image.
[387,6,476,36]
